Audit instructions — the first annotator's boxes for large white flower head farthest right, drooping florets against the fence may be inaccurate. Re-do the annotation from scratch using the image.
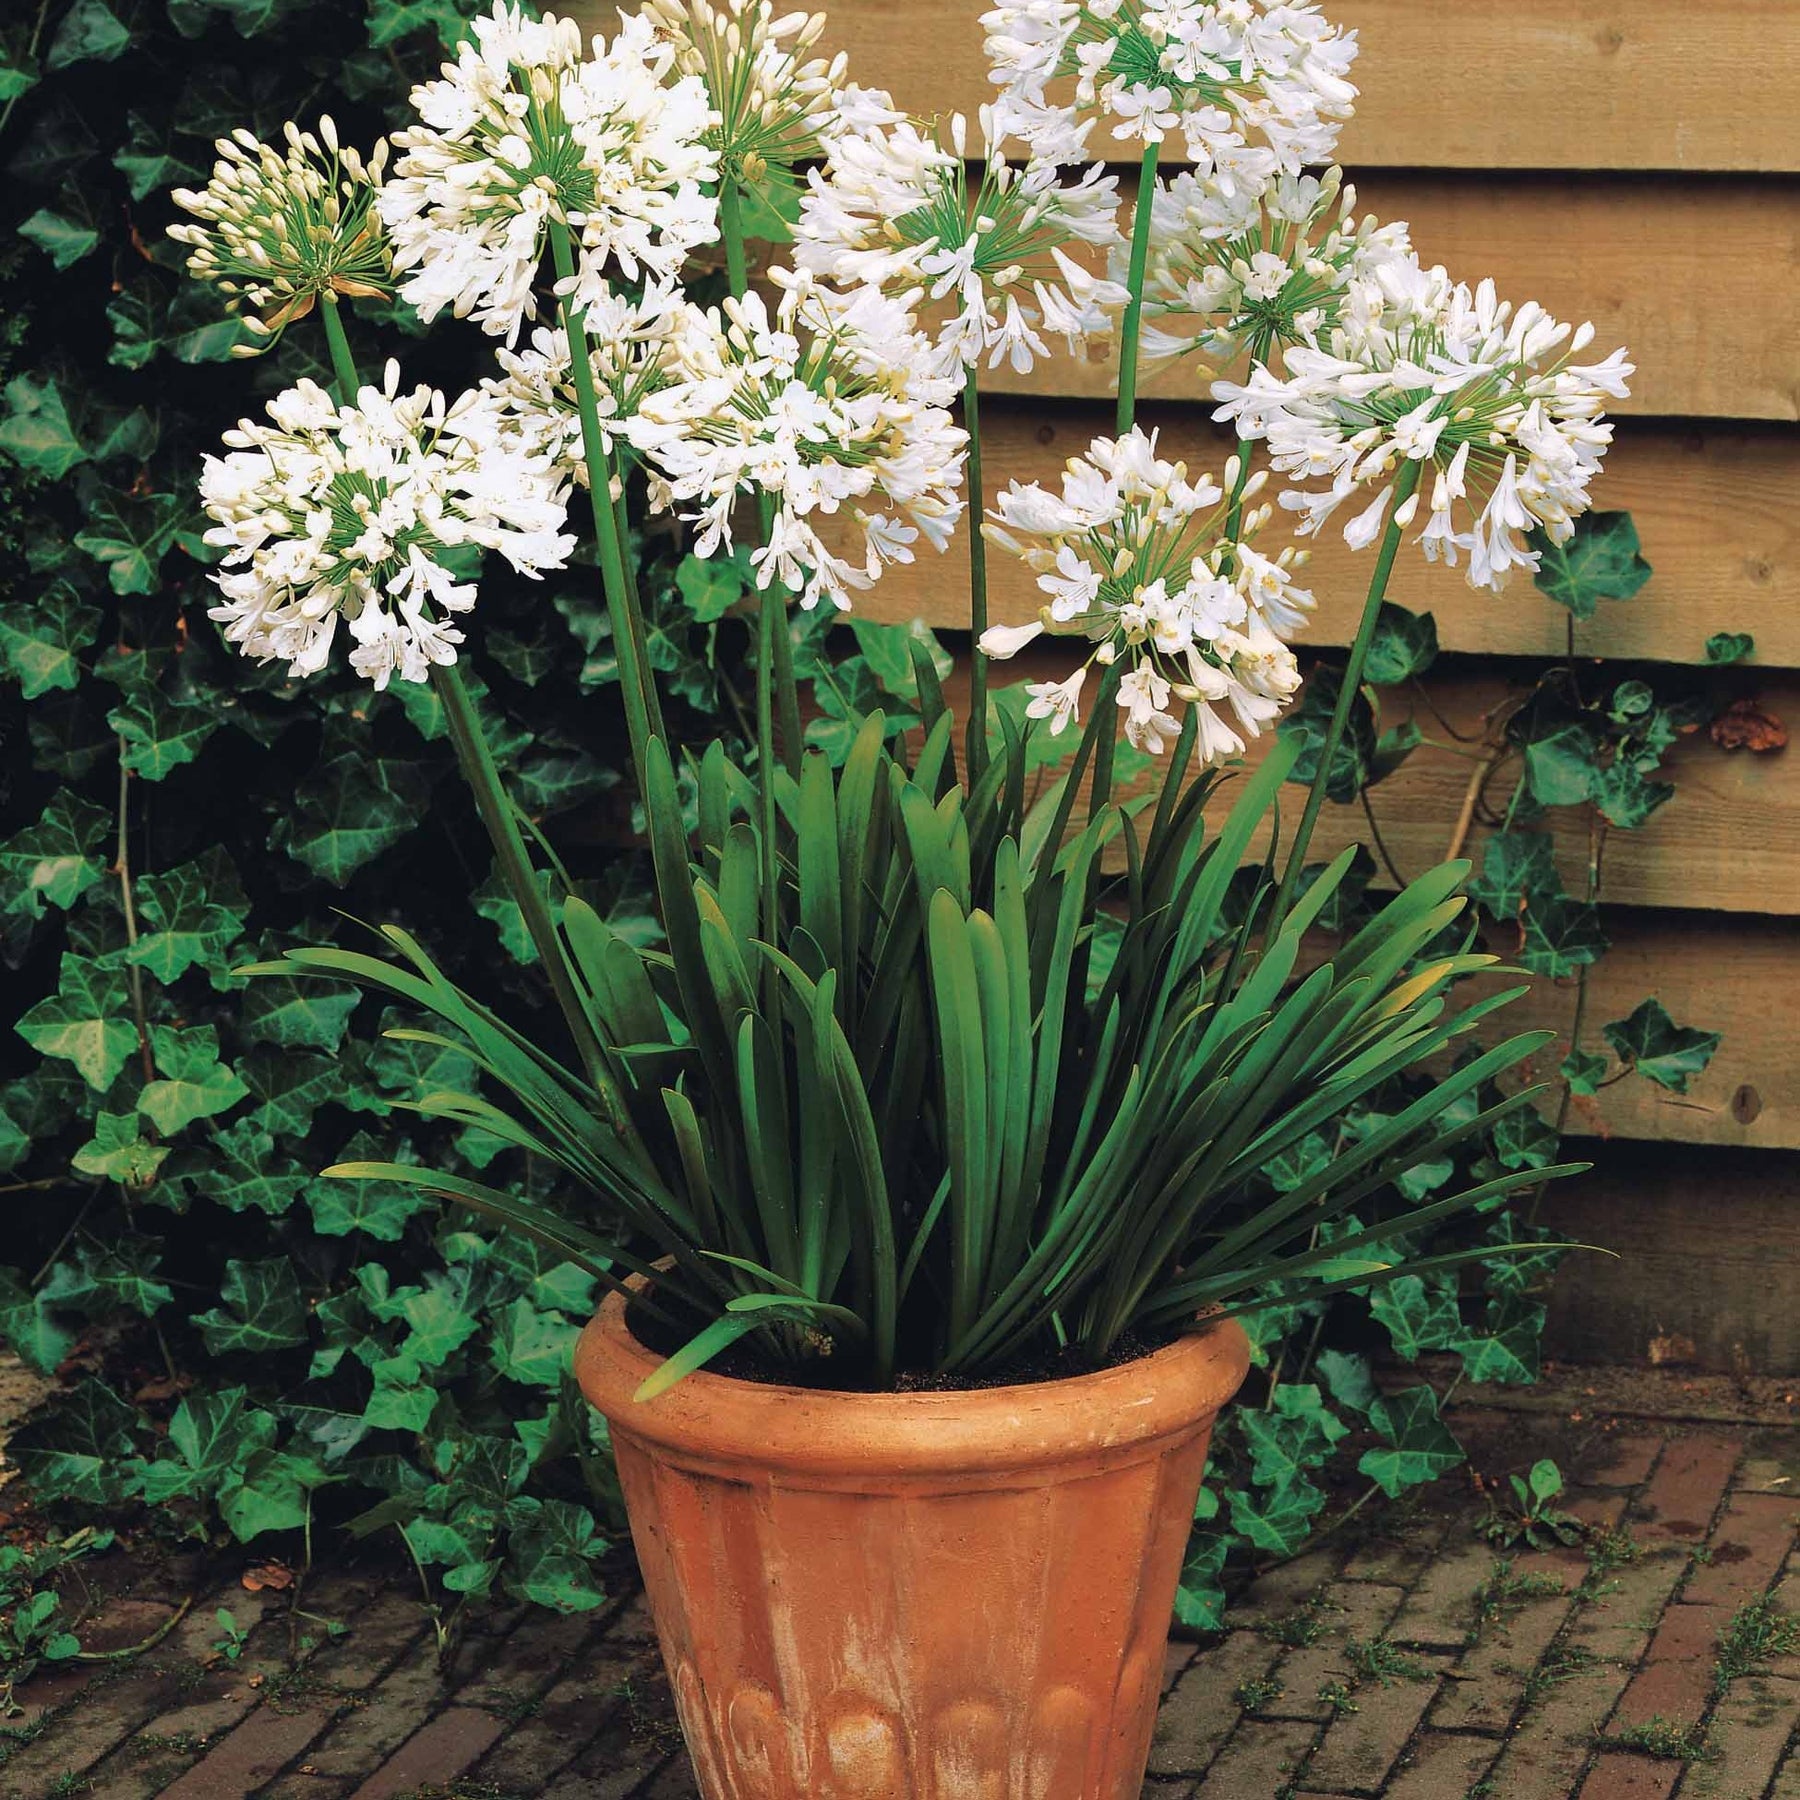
[1213,259,1633,592]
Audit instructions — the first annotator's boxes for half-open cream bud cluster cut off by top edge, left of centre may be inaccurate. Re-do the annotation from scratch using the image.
[644,0,848,182]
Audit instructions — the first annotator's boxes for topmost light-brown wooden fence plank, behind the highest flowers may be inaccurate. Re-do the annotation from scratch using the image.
[784,0,1800,169]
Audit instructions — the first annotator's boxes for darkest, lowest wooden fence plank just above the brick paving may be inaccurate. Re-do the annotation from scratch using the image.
[1544,1145,1800,1375]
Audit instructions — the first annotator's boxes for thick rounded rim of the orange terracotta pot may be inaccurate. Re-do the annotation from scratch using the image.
[574,1276,1249,1478]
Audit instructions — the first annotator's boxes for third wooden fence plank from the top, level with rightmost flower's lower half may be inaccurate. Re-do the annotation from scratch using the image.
[860,401,1800,668]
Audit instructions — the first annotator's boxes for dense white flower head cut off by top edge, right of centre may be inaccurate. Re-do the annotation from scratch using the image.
[981,0,1355,180]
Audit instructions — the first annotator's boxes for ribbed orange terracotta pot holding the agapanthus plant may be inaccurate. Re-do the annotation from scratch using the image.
[576,1296,1249,1800]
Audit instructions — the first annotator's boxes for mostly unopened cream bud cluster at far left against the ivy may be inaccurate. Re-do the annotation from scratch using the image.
[169,117,391,356]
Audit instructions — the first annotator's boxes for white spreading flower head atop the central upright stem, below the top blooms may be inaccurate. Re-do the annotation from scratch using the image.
[794,108,1129,374]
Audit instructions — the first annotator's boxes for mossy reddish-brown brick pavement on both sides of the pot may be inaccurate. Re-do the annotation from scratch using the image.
[0,1418,1800,1800]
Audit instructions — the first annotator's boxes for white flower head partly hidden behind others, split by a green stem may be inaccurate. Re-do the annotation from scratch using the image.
[481,283,713,468]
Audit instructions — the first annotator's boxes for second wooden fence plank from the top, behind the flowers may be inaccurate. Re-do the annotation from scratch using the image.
[983,173,1800,421]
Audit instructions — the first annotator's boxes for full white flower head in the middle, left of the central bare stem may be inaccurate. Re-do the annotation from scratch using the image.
[637,270,968,608]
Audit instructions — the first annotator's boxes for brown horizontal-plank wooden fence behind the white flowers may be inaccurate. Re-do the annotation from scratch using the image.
[594,0,1800,1373]
